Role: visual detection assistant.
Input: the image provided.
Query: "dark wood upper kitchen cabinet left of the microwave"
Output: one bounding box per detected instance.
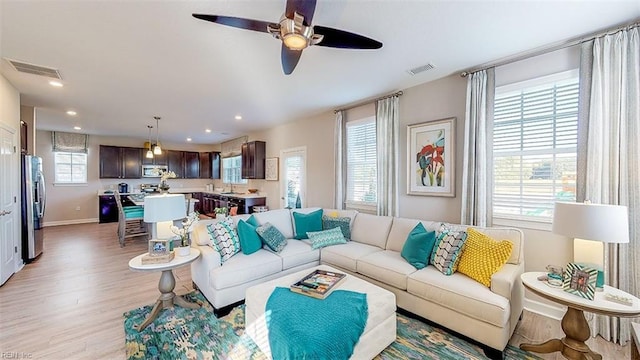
[100,145,142,179]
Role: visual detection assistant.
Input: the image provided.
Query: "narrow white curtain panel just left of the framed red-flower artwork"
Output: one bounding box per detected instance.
[376,95,399,216]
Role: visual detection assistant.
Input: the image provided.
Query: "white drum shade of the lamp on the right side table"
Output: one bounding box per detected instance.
[552,202,629,243]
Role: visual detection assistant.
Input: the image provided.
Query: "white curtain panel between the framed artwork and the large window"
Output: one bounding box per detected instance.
[460,68,495,226]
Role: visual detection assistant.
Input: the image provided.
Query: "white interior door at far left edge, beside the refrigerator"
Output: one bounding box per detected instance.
[0,125,19,284]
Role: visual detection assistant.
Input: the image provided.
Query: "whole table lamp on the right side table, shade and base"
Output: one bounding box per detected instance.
[552,202,629,289]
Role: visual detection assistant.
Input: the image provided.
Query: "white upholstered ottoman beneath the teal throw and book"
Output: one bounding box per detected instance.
[244,265,396,359]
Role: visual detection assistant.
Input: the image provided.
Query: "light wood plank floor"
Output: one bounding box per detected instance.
[0,224,630,360]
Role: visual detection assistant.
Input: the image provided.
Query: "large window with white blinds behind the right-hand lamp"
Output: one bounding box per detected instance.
[493,70,578,222]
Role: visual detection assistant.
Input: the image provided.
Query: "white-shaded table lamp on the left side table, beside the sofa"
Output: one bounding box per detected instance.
[144,194,186,239]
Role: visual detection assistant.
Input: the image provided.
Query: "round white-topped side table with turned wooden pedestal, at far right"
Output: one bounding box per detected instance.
[520,272,640,360]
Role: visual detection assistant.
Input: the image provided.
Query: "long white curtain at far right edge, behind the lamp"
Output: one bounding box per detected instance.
[583,27,640,344]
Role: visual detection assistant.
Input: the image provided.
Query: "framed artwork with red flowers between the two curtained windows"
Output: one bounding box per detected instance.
[407,117,456,197]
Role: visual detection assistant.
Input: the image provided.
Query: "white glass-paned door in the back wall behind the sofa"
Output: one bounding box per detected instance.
[280,146,307,208]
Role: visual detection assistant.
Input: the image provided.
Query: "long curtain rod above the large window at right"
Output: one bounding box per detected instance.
[460,19,640,77]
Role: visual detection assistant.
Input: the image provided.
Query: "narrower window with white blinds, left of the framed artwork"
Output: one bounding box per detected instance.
[346,117,378,207]
